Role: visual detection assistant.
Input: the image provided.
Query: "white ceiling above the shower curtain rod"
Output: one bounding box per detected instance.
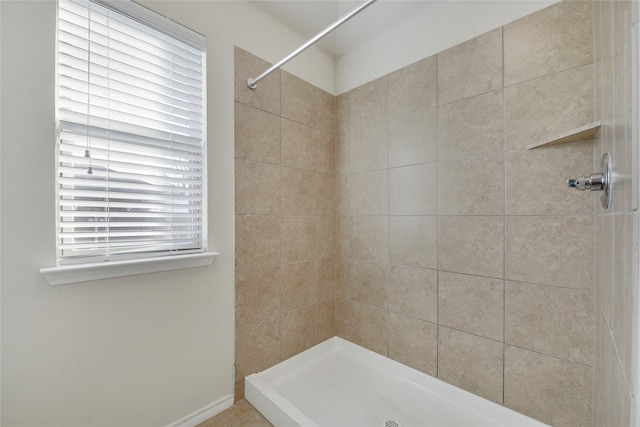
[251,0,439,59]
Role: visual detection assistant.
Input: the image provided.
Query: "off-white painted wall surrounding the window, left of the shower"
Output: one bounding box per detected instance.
[0,0,334,427]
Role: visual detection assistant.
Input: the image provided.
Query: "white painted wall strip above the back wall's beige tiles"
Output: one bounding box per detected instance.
[335,0,557,94]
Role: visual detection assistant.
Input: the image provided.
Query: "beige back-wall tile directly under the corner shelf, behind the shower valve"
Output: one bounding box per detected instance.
[506,142,599,215]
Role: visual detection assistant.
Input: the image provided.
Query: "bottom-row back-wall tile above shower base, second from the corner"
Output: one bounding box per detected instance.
[350,302,389,356]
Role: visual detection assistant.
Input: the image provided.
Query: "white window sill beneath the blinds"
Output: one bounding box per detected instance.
[40,252,220,285]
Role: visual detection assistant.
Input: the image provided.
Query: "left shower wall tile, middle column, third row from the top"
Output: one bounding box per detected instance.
[281,167,316,215]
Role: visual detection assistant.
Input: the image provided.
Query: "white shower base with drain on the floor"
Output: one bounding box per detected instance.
[245,337,546,427]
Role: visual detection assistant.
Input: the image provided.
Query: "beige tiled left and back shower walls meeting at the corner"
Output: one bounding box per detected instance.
[235,2,597,426]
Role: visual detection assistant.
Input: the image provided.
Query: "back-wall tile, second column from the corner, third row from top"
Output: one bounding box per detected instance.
[350,169,389,215]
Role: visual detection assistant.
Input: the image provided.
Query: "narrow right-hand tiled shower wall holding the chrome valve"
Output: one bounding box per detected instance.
[593,1,640,427]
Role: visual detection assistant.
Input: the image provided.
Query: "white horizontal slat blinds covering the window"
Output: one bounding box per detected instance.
[57,0,206,264]
